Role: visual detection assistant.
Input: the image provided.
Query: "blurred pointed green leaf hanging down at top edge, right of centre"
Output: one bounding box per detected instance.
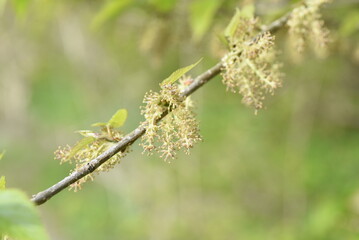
[189,0,221,42]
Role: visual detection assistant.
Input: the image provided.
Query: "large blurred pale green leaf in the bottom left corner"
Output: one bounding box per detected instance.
[0,189,49,240]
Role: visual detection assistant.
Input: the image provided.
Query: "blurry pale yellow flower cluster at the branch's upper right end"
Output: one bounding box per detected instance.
[287,0,330,62]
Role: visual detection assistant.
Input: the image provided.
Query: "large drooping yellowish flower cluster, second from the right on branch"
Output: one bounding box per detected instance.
[222,17,282,111]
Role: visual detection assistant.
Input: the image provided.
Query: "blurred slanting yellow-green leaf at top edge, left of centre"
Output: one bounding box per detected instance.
[91,0,133,29]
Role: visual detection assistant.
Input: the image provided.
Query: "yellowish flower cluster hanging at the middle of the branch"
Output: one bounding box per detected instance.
[141,79,201,161]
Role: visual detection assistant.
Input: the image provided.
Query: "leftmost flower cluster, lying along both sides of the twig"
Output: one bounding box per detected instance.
[55,127,128,192]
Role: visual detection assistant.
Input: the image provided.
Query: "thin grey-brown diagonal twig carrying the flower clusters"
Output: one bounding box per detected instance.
[31,14,290,205]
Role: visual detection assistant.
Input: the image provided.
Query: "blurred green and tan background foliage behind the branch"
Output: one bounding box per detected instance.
[0,0,359,240]
